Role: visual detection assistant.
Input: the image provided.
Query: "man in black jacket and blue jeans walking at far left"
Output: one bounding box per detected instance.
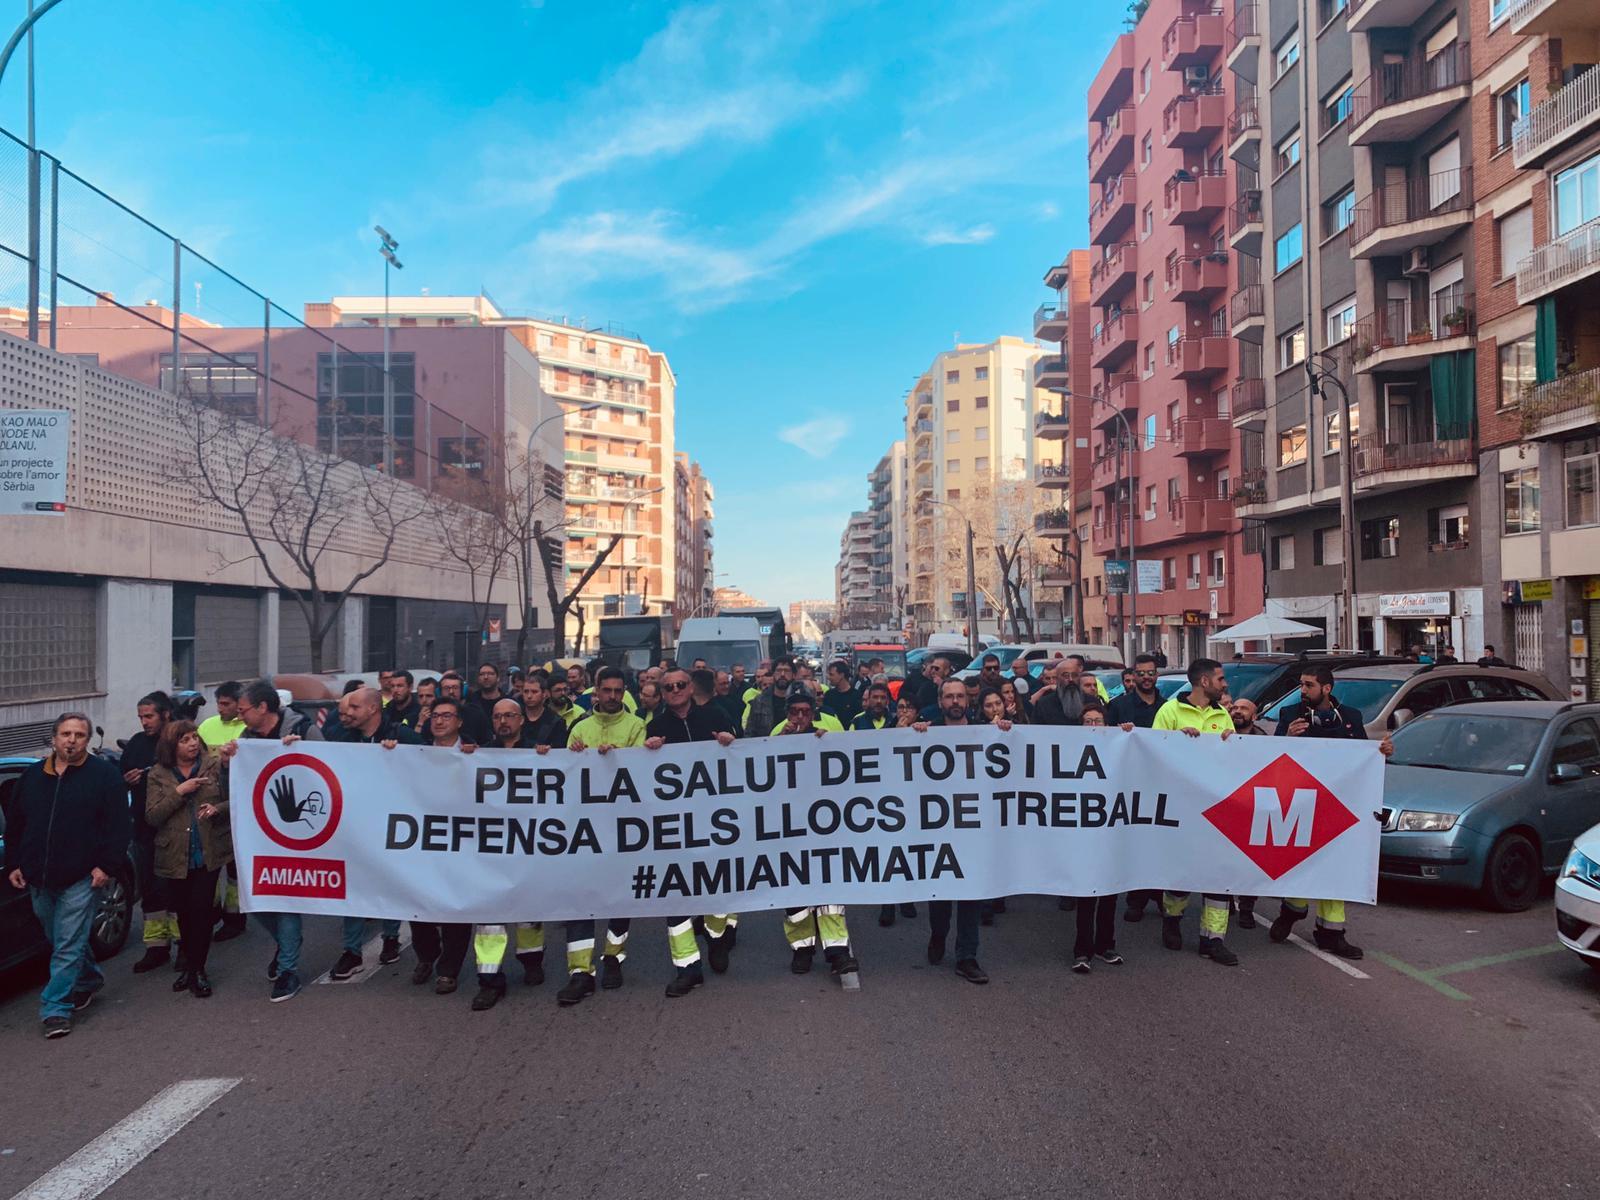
[5,712,133,1038]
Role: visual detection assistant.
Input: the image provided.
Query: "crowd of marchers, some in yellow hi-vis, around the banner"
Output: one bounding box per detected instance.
[5,654,1390,1037]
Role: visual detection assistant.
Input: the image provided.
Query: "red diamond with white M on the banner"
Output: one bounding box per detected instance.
[1205,754,1357,878]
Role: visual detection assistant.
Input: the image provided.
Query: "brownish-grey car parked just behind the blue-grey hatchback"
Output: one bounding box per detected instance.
[1261,662,1562,741]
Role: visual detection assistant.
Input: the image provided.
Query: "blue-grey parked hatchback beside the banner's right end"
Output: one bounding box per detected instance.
[1378,699,1600,912]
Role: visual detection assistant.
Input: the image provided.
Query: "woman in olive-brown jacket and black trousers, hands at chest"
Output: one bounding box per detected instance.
[144,722,234,1000]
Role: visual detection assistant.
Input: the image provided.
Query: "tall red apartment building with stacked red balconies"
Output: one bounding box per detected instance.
[1086,0,1262,662]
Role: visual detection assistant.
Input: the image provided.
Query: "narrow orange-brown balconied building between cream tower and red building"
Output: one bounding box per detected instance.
[1034,250,1106,642]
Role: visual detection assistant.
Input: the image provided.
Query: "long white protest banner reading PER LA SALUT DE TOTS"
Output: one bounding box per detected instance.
[230,726,1382,922]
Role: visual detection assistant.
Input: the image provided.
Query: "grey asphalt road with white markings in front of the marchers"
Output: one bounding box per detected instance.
[0,893,1600,1200]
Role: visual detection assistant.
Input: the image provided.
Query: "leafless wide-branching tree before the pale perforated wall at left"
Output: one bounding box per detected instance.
[173,397,426,672]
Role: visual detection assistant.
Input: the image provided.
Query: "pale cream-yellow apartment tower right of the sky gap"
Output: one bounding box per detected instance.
[904,336,1040,637]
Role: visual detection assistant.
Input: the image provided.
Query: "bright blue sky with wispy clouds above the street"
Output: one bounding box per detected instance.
[0,0,1123,603]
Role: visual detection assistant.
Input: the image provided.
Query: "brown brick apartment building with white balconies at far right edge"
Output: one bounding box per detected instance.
[1470,0,1600,698]
